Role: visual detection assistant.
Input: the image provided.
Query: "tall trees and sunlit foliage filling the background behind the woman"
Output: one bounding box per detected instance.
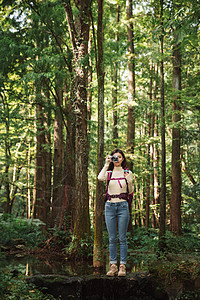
[0,0,200,299]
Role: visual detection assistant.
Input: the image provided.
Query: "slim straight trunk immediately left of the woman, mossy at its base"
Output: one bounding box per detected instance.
[93,0,104,268]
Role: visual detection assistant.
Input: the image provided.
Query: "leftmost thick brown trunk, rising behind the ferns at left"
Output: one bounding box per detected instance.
[32,82,51,229]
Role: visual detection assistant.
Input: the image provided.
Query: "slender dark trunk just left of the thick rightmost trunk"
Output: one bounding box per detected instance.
[159,0,166,249]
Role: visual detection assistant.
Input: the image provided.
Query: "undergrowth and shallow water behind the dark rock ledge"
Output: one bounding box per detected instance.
[0,216,200,299]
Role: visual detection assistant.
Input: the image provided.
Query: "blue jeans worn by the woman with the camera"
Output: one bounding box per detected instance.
[105,201,129,264]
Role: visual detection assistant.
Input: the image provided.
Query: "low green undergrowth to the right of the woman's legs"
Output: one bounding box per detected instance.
[127,228,200,270]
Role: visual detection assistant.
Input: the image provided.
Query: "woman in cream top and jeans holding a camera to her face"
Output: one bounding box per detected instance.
[98,149,133,276]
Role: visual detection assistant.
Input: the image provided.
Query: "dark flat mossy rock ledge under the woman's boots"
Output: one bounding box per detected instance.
[27,272,168,300]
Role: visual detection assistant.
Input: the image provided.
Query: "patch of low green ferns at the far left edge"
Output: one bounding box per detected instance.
[0,214,44,247]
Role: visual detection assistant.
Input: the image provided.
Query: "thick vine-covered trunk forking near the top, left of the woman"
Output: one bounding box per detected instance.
[63,0,90,241]
